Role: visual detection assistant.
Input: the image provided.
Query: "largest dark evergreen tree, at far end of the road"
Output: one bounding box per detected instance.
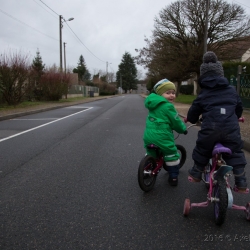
[116,52,138,93]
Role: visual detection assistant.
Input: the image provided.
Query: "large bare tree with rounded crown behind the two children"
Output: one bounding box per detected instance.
[136,0,250,86]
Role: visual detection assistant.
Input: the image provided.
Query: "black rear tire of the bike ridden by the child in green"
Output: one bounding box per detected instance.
[138,155,156,192]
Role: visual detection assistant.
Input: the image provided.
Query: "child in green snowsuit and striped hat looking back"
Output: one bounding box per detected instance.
[143,79,186,186]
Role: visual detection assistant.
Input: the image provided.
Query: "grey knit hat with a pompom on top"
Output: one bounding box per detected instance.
[200,51,224,76]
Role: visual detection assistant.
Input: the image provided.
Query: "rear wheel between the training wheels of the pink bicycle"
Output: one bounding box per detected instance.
[213,177,228,225]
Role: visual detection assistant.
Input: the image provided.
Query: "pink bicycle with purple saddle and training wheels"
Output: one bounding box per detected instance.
[183,117,250,225]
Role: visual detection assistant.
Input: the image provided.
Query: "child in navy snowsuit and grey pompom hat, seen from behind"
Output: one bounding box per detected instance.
[187,51,247,192]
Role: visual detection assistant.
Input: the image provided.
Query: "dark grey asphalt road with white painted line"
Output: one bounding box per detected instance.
[0,95,250,250]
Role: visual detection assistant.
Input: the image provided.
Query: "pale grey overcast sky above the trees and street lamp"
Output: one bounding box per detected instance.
[0,0,250,79]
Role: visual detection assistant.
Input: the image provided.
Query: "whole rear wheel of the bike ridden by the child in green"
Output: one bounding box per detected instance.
[138,155,156,192]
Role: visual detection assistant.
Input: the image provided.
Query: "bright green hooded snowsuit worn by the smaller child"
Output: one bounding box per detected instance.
[143,93,186,161]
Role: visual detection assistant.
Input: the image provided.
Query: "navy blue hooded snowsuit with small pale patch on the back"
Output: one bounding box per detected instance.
[187,74,243,164]
